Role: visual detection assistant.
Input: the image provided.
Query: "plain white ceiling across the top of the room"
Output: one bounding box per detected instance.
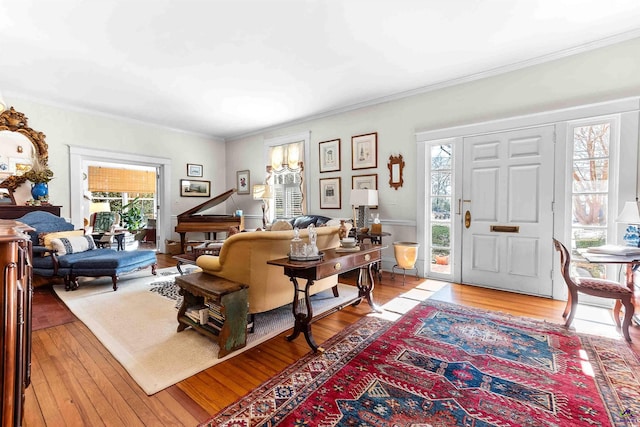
[0,0,640,138]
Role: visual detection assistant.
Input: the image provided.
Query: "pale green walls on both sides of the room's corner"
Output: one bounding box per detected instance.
[3,39,640,231]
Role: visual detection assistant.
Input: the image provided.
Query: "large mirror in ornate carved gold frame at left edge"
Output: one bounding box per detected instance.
[0,107,49,195]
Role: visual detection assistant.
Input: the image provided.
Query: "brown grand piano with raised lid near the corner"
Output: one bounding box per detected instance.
[176,189,244,252]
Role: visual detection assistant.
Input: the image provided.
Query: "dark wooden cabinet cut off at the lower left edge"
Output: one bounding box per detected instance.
[0,220,33,427]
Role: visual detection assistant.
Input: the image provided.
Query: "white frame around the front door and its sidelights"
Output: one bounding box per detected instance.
[415,97,640,299]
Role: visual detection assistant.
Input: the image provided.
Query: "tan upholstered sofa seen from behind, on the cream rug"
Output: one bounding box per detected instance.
[196,226,340,314]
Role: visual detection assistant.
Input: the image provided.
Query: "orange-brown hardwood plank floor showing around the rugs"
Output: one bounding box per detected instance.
[24,254,640,427]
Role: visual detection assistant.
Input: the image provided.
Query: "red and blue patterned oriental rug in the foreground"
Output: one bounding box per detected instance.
[202,300,640,427]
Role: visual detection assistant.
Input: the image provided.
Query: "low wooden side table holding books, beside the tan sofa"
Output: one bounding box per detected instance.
[176,273,249,358]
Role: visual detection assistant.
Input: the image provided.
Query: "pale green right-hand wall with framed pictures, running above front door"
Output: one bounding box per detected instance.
[227,39,640,231]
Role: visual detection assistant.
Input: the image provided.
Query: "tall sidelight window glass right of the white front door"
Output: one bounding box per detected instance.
[571,122,611,278]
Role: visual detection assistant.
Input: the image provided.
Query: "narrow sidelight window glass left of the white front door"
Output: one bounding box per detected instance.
[429,144,453,274]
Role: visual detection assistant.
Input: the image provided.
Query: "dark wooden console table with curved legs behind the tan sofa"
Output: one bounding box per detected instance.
[267,244,385,352]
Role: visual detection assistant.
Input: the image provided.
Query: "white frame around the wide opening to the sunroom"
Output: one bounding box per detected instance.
[69,145,171,253]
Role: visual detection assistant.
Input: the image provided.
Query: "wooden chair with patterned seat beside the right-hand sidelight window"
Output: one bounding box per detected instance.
[553,239,634,341]
